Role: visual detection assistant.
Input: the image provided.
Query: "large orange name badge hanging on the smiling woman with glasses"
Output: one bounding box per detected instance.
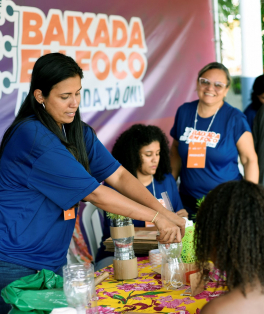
[187,142,206,168]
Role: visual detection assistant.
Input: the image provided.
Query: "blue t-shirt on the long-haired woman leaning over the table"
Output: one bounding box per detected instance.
[0,118,120,271]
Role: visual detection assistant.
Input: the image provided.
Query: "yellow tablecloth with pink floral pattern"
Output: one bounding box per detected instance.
[96,257,224,314]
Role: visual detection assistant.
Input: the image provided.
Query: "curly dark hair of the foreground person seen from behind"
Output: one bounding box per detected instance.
[194,180,264,295]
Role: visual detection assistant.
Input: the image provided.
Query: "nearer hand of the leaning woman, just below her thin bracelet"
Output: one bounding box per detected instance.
[154,213,185,244]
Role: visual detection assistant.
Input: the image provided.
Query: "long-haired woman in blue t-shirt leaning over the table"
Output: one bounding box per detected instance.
[0,53,185,314]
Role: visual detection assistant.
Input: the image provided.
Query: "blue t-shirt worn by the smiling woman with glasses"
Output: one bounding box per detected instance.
[170,100,251,199]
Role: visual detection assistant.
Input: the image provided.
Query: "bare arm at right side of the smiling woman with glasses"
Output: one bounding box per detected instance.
[236,131,259,184]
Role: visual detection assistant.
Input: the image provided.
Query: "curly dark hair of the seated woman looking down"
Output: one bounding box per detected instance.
[112,124,171,181]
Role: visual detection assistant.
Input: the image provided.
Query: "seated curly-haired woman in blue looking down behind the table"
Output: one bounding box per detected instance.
[96,124,188,262]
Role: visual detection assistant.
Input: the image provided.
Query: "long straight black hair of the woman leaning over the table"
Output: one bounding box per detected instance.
[0,53,89,170]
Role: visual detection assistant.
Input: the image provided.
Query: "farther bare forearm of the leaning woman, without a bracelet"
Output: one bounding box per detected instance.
[105,166,185,236]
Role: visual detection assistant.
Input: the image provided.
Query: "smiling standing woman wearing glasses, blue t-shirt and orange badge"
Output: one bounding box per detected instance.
[170,62,259,217]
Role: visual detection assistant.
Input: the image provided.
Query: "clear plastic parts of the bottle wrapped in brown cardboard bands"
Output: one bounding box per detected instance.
[110,218,135,260]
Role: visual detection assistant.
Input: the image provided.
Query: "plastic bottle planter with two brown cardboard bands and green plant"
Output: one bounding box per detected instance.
[106,213,138,280]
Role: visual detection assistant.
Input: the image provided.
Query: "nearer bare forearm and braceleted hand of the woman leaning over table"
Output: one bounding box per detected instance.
[84,184,182,243]
